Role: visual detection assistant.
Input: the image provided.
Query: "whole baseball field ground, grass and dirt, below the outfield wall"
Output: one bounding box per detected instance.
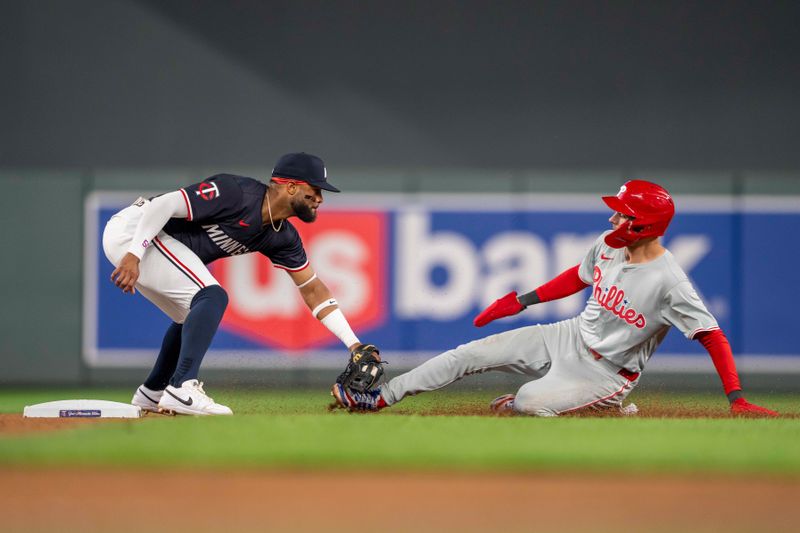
[0,388,800,533]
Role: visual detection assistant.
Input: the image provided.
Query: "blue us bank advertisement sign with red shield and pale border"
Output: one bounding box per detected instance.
[84,193,800,370]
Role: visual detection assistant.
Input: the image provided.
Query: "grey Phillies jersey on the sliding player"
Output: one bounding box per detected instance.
[579,232,719,372]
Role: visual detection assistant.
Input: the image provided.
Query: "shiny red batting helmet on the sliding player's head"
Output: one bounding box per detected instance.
[603,180,675,248]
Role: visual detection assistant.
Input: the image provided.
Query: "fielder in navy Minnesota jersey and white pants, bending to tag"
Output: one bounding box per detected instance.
[103,153,376,415]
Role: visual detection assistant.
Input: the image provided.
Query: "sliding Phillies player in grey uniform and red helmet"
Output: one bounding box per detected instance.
[332,180,777,416]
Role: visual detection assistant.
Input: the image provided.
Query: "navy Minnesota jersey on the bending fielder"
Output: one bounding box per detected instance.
[164,174,308,271]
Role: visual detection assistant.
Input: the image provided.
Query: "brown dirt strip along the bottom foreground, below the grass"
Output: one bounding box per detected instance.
[0,463,800,533]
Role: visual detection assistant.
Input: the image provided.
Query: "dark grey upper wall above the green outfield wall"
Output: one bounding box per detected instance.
[0,0,800,169]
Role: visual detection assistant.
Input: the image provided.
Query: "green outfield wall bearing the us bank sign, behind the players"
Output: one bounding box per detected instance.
[0,169,800,385]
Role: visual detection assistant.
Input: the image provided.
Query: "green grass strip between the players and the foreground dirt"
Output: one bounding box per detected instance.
[0,390,800,477]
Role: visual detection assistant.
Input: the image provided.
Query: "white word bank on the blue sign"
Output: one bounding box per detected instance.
[395,210,711,321]
